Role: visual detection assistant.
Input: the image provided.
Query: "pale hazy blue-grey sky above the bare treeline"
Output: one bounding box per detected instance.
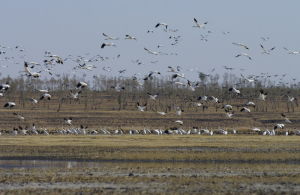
[0,0,300,80]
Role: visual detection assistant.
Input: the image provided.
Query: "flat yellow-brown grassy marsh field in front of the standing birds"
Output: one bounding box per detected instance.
[0,135,300,194]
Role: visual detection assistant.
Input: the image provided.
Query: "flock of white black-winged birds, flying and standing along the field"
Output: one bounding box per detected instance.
[0,18,300,135]
